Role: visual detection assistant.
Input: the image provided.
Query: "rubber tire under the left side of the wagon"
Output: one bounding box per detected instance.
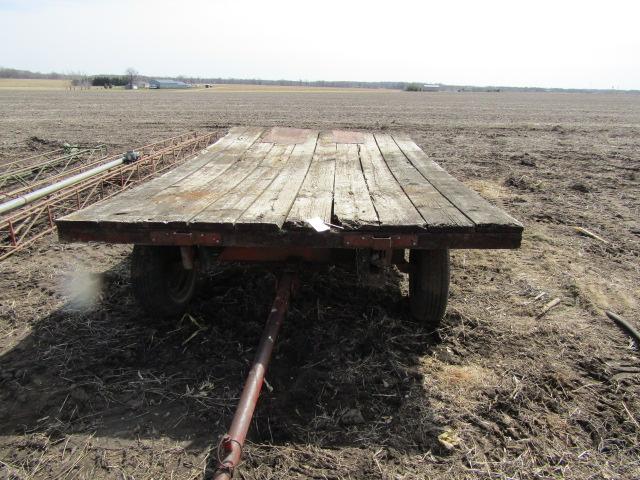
[131,245,198,318]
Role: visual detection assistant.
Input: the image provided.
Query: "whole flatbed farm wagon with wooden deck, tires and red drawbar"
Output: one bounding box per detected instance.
[56,127,523,478]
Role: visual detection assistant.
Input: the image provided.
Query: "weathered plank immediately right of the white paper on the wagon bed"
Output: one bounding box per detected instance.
[333,143,379,229]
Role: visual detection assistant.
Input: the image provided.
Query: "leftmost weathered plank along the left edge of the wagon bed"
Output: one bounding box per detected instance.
[68,127,247,220]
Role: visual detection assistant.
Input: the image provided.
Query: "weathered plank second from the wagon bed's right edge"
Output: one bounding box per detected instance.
[375,133,474,230]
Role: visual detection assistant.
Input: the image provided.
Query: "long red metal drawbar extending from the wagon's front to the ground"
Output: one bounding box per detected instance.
[213,272,295,480]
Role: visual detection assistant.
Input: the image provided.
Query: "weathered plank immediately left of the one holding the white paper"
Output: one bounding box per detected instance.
[236,131,318,230]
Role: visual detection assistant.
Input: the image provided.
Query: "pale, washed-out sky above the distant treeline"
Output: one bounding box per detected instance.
[0,0,640,89]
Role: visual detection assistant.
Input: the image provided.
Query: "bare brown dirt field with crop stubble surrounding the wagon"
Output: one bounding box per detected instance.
[0,89,640,480]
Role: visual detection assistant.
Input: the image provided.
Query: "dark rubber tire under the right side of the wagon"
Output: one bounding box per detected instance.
[409,250,449,330]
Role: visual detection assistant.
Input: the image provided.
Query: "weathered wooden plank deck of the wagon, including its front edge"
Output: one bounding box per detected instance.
[56,127,523,249]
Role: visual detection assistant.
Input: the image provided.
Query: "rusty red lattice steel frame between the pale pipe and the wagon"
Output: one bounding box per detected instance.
[0,132,215,261]
